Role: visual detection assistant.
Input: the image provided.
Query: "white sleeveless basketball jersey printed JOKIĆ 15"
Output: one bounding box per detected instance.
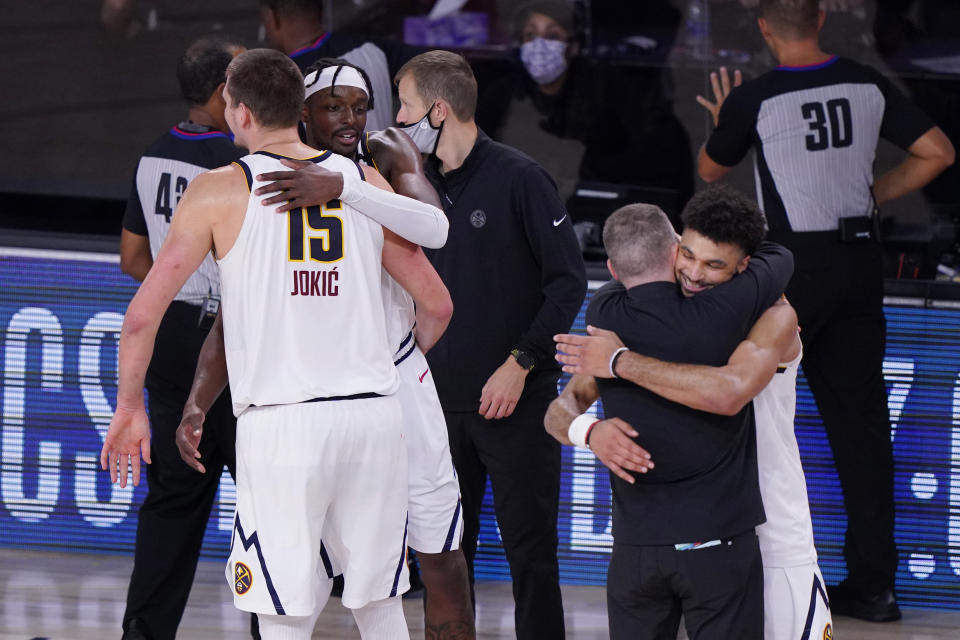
[218,151,399,416]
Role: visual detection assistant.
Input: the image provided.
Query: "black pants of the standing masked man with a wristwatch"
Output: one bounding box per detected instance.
[444,372,564,640]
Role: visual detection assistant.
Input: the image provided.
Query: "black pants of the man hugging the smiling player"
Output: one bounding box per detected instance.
[607,530,763,640]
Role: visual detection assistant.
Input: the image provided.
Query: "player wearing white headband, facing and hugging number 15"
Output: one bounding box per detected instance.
[178,58,475,638]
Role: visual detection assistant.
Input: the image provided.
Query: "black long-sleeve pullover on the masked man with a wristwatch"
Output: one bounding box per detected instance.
[426,131,586,411]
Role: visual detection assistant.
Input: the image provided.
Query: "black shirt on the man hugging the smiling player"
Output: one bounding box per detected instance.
[587,243,793,545]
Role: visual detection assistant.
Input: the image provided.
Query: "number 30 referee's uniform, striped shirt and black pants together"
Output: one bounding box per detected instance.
[706,57,934,596]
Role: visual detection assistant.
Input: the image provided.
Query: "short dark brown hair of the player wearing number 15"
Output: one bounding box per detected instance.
[227,49,304,129]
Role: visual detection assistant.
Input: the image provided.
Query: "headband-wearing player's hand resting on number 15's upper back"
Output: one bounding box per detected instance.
[253,158,343,213]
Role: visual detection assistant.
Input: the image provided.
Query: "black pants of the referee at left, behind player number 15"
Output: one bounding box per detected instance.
[123,302,236,640]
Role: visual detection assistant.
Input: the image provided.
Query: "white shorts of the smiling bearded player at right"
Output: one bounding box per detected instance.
[763,562,833,640]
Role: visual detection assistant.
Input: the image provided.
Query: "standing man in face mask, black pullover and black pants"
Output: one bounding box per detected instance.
[395,51,586,638]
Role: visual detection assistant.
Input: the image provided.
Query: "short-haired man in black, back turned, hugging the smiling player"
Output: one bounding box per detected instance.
[587,201,793,640]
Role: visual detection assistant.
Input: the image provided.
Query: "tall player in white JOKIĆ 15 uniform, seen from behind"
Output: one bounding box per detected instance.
[101,50,448,640]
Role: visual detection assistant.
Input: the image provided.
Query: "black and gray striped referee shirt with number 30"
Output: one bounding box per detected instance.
[706,56,934,231]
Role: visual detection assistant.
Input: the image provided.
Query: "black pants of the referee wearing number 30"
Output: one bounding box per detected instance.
[770,232,897,596]
